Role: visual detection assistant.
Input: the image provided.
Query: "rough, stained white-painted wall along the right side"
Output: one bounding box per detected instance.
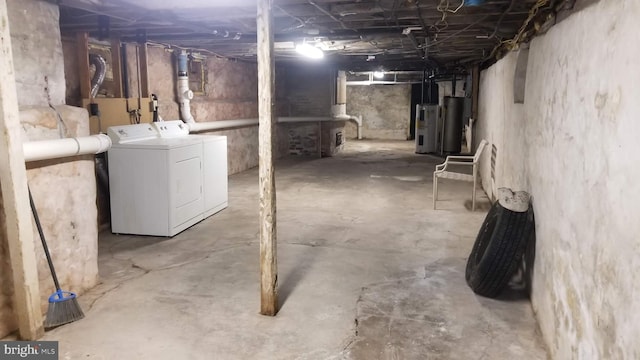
[477,0,640,359]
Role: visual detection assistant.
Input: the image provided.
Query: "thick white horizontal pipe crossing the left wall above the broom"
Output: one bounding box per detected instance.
[22,134,111,162]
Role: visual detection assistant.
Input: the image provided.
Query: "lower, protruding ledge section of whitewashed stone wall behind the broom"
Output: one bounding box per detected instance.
[0,105,98,337]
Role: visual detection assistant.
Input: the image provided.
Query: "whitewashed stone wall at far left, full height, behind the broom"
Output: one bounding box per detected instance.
[0,0,98,337]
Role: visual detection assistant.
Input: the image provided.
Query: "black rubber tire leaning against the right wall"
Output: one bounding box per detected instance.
[465,202,534,298]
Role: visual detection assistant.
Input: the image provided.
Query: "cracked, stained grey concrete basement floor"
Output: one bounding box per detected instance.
[45,141,546,359]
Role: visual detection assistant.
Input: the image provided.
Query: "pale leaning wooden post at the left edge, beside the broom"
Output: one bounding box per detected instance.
[0,0,44,340]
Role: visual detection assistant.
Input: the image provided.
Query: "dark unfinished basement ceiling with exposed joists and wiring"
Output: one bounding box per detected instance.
[57,0,564,70]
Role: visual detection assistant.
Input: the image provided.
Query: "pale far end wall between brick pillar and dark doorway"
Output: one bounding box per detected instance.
[345,84,411,140]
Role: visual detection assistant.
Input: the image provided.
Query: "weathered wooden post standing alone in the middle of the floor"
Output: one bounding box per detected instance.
[256,0,278,316]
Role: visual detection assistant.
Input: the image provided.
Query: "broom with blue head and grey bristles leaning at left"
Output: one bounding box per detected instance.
[29,189,84,329]
